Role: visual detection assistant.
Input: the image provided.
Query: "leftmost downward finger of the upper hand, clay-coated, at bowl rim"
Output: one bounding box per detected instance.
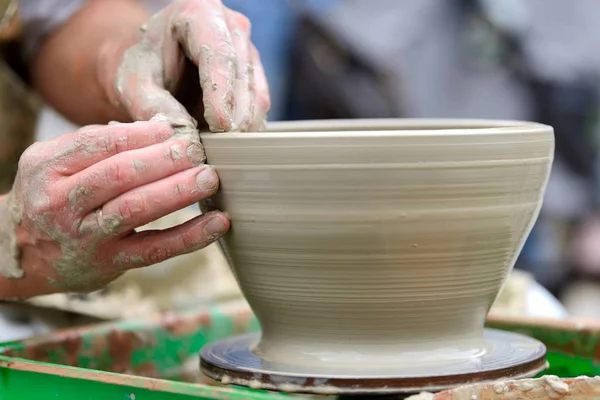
[173,0,238,132]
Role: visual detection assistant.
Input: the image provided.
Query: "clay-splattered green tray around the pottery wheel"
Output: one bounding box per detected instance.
[0,304,600,400]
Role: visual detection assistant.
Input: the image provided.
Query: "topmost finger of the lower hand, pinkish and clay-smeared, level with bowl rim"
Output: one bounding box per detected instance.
[50,122,174,175]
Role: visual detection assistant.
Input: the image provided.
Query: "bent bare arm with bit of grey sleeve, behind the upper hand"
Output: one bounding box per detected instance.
[21,0,149,125]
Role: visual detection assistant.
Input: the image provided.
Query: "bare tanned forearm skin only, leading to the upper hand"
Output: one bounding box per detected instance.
[31,0,149,125]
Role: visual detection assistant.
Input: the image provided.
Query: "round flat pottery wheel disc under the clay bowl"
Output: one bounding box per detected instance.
[200,329,547,395]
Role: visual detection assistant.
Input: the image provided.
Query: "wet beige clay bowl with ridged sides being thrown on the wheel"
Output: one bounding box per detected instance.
[202,120,554,375]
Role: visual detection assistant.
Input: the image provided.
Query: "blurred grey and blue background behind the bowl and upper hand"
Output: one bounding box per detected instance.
[38,0,600,318]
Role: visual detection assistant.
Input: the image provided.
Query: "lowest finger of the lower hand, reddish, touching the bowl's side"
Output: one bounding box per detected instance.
[113,212,230,269]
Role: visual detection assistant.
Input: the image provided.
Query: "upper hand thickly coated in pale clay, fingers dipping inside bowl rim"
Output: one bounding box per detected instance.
[99,0,269,133]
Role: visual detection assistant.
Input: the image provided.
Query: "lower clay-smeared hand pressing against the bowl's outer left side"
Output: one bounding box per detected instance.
[0,122,229,297]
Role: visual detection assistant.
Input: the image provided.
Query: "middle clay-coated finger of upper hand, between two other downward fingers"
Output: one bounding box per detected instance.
[225,10,255,132]
